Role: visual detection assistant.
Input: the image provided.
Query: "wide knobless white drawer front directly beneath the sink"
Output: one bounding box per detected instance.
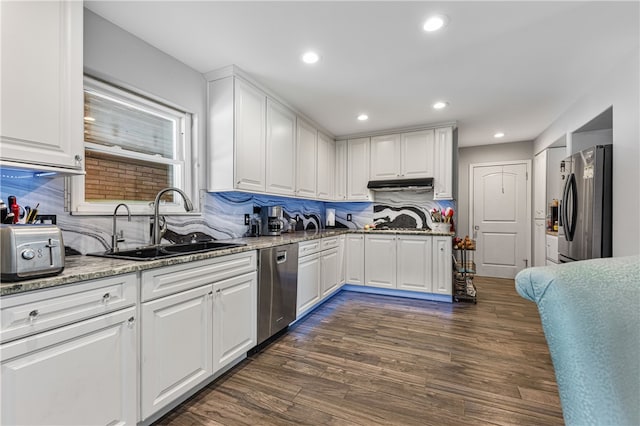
[142,250,257,302]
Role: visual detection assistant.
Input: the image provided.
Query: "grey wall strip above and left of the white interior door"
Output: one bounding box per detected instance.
[456,141,533,237]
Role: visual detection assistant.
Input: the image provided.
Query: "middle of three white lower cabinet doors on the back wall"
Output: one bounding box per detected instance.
[396,235,433,293]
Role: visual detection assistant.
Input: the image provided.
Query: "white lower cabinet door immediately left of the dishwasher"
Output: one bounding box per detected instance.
[213,272,258,371]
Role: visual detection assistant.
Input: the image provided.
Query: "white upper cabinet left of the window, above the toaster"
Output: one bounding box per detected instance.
[0,1,84,173]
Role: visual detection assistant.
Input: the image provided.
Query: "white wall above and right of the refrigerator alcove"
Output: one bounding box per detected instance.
[534,48,640,256]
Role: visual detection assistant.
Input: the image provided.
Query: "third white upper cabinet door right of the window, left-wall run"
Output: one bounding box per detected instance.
[296,119,318,197]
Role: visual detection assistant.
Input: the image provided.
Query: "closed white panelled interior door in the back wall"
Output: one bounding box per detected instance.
[469,160,531,278]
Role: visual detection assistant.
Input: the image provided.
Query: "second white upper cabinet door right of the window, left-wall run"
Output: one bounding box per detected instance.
[266,99,296,195]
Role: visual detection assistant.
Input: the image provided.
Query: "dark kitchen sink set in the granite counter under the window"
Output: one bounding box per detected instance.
[87,241,246,260]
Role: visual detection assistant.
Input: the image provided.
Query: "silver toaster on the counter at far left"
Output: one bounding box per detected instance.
[0,225,64,281]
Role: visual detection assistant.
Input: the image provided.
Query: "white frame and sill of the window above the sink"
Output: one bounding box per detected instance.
[65,75,200,216]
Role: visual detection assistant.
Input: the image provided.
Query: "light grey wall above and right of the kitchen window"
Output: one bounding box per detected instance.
[84,9,207,192]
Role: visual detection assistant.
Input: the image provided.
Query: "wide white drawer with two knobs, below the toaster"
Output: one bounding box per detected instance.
[0,274,137,342]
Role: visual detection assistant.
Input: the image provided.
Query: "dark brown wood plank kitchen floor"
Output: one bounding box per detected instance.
[157,277,563,426]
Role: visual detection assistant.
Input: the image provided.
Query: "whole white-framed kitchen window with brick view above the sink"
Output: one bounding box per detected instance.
[71,76,195,214]
